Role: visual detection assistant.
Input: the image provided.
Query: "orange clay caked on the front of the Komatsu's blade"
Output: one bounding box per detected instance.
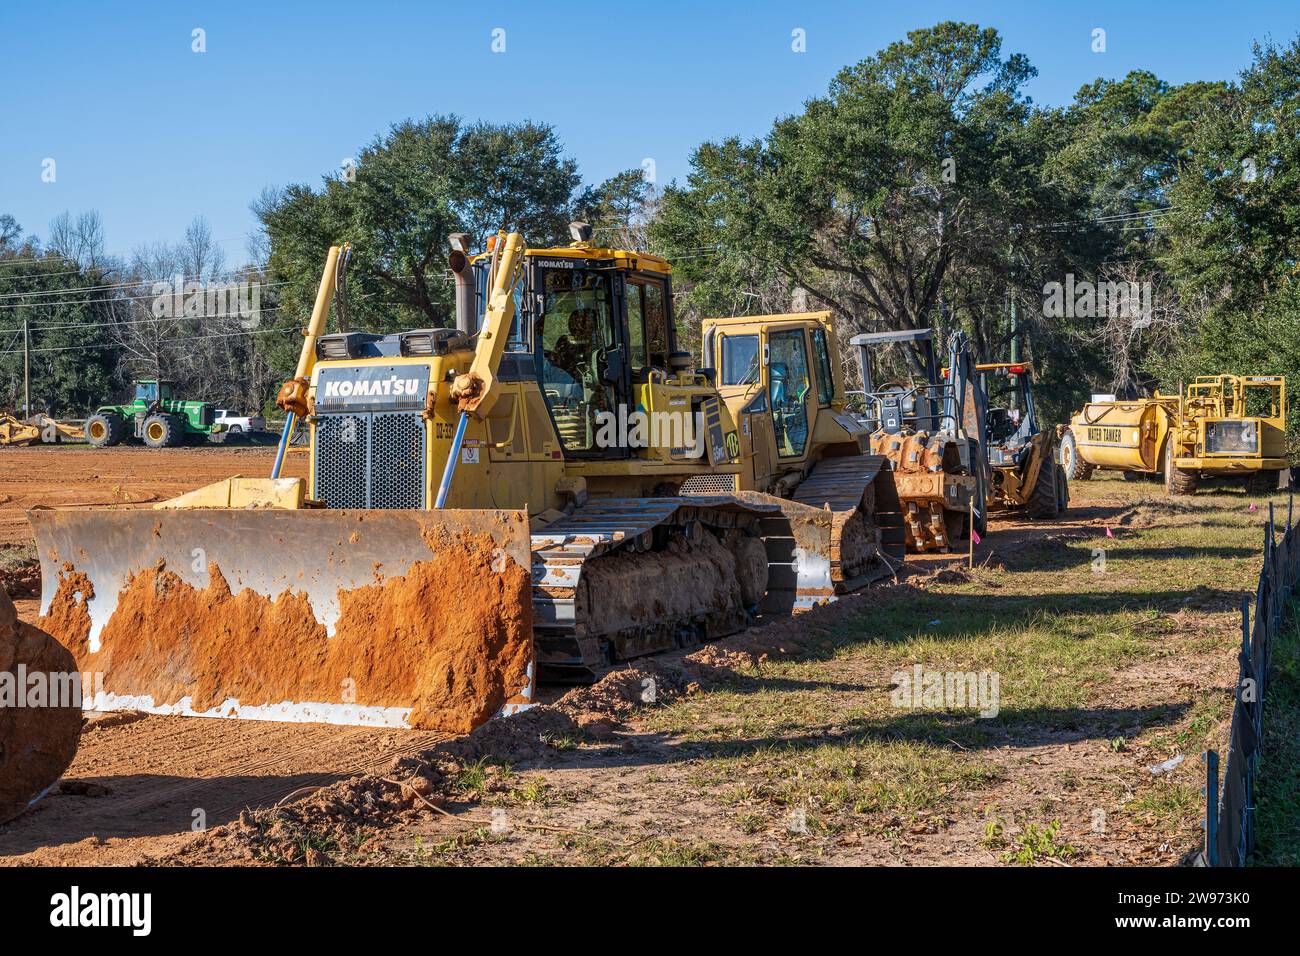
[40,535,532,734]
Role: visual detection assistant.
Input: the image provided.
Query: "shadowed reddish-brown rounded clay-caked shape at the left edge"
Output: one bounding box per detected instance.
[0,591,82,823]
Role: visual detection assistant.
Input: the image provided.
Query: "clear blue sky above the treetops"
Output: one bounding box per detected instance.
[0,0,1300,261]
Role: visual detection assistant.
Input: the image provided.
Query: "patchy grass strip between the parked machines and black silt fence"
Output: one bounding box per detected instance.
[361,479,1284,865]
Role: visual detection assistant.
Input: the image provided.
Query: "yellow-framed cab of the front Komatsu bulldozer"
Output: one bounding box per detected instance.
[458,233,738,476]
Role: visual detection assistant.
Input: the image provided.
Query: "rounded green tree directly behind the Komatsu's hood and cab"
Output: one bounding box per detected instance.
[254,116,579,369]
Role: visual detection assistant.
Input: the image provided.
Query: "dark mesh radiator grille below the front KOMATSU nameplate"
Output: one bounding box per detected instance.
[316,412,426,509]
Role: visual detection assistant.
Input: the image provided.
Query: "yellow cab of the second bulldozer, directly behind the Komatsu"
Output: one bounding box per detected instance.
[703,312,866,488]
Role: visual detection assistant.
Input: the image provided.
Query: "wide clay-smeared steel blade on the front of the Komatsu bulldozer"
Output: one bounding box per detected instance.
[27,509,534,732]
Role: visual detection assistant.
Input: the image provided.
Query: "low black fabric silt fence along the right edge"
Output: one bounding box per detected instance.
[1195,498,1300,866]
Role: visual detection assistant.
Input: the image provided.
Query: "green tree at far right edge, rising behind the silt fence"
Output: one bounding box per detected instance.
[1149,40,1300,424]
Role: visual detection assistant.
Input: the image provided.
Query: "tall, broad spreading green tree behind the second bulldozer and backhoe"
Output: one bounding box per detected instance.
[653,22,1086,403]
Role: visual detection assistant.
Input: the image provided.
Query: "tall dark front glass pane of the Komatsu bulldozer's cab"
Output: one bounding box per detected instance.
[536,269,616,451]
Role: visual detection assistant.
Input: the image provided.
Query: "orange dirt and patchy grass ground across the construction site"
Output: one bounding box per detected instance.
[0,449,1282,865]
